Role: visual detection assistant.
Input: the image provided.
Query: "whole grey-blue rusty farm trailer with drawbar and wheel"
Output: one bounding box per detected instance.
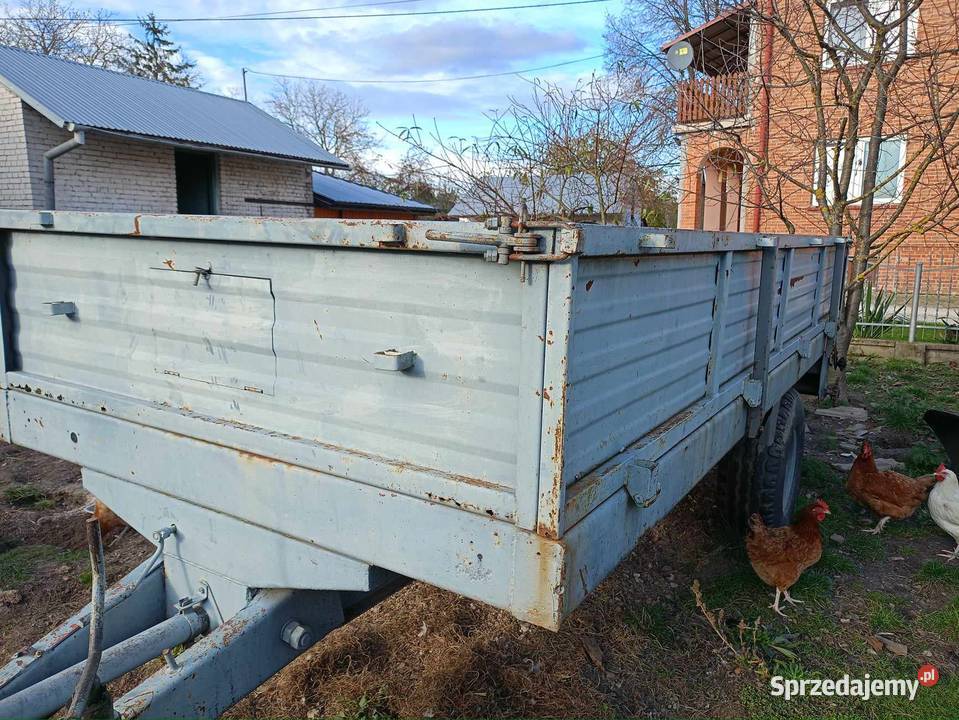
[0,211,846,717]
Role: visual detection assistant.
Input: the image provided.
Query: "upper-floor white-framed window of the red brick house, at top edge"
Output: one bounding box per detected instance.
[823,0,919,67]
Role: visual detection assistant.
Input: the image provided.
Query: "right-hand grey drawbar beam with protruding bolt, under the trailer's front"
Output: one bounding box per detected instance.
[114,590,344,718]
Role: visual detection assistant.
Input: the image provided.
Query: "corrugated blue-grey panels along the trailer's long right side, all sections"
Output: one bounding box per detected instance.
[563,247,835,484]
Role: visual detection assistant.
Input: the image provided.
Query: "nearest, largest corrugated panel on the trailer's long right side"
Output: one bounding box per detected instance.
[563,254,718,483]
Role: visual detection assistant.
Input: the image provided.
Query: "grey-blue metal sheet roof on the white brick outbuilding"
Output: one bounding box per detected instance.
[0,45,347,168]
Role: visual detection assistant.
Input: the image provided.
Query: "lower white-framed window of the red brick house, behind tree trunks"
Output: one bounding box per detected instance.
[813,136,906,205]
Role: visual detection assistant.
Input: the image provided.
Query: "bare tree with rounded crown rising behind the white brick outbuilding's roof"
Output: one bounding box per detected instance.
[267,79,378,180]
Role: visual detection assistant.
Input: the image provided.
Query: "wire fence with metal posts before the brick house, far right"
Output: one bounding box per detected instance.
[856,250,959,343]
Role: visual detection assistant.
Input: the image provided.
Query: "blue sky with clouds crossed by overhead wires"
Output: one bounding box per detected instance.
[88,0,623,170]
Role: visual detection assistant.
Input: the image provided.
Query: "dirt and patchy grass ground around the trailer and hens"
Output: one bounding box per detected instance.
[0,361,959,718]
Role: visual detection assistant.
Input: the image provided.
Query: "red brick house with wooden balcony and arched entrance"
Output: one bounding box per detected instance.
[663,0,959,270]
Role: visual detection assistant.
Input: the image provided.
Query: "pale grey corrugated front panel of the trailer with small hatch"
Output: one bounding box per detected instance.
[11,232,523,496]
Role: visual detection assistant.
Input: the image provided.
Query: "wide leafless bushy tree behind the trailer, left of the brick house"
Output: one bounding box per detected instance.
[386,75,663,222]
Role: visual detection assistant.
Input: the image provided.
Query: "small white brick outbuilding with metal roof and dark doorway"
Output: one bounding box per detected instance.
[0,46,346,217]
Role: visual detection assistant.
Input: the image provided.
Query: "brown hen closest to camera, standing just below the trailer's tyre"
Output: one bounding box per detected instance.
[746,500,829,617]
